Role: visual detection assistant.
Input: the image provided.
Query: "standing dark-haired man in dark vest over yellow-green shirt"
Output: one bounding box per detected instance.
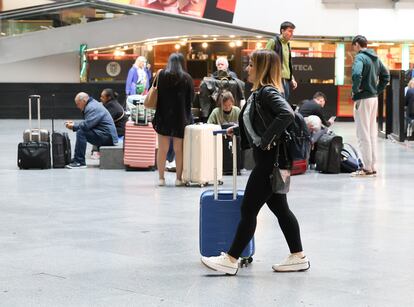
[266,21,298,100]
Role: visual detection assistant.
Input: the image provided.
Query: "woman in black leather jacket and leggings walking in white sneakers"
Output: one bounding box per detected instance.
[201,50,310,275]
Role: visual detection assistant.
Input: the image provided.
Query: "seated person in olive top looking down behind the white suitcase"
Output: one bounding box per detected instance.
[207,91,240,125]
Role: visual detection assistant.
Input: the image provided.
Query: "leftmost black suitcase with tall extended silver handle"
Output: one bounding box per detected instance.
[17,95,51,169]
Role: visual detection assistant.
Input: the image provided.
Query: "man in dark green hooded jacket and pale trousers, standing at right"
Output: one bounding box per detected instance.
[351,35,390,177]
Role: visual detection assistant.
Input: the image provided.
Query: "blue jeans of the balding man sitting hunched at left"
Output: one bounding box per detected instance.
[73,129,114,165]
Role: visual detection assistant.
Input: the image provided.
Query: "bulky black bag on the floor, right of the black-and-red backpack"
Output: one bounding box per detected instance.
[315,134,343,174]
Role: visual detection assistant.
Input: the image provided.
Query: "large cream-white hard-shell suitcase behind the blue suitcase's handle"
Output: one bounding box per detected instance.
[183,124,223,187]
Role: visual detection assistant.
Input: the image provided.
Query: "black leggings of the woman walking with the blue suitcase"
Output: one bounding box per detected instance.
[228,148,302,259]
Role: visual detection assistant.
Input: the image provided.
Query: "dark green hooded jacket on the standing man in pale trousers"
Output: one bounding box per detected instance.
[352,49,390,101]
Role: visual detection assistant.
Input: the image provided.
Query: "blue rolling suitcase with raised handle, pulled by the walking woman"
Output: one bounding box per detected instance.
[200,130,254,265]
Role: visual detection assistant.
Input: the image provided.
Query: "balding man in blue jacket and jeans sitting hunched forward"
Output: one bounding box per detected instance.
[65,92,118,168]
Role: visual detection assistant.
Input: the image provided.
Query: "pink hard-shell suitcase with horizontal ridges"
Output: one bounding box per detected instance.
[124,121,157,170]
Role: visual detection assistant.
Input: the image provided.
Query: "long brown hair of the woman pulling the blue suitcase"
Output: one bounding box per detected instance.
[250,49,283,93]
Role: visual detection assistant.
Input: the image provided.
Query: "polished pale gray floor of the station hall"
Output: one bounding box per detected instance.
[0,120,414,306]
